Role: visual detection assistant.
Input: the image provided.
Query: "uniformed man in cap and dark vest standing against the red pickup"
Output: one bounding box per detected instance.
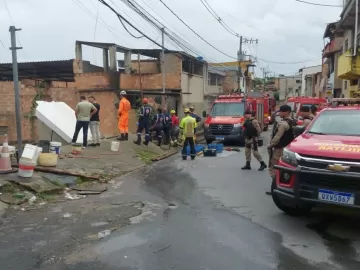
[266,105,296,195]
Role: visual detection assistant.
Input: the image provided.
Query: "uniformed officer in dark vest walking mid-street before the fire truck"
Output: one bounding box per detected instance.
[241,111,267,171]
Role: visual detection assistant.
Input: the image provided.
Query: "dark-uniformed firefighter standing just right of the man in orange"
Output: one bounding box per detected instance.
[134,98,153,145]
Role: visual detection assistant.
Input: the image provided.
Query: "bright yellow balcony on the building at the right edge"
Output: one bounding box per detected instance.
[338,48,360,80]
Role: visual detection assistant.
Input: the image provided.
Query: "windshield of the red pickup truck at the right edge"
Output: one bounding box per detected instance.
[308,110,360,136]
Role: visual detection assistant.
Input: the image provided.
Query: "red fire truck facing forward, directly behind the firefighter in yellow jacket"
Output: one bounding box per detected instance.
[203,94,269,145]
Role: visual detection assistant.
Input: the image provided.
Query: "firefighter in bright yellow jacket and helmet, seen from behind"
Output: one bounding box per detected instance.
[179,108,197,160]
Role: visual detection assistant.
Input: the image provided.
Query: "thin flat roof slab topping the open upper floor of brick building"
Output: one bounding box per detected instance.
[76,40,206,63]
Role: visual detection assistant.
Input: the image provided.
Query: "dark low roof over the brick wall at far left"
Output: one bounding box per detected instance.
[0,59,74,82]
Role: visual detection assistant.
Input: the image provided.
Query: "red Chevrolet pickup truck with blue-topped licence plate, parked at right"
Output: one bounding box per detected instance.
[271,99,360,215]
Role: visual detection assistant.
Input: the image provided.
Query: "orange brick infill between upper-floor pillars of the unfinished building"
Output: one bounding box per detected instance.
[120,73,181,90]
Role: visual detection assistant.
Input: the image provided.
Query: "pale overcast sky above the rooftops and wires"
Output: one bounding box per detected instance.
[0,0,342,75]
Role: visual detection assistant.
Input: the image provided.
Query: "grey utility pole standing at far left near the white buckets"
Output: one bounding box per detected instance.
[9,26,22,158]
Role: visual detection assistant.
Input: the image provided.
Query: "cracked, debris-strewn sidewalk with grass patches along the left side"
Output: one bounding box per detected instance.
[0,135,177,214]
